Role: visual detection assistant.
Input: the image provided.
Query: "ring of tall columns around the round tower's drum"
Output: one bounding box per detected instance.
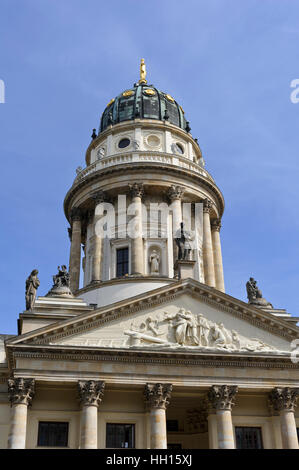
[69,183,224,292]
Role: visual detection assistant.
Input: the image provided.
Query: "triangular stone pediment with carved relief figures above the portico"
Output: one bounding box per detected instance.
[9,279,299,355]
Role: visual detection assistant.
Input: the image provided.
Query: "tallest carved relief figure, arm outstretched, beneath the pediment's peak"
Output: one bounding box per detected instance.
[165,308,199,346]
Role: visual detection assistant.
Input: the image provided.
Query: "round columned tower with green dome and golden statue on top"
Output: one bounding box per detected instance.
[64,59,224,306]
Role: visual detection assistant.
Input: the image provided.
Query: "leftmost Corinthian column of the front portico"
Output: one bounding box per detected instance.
[8,378,35,449]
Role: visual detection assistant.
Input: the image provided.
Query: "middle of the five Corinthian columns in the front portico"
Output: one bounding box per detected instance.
[144,383,172,449]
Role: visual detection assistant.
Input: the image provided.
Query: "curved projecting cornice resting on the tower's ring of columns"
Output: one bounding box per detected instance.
[64,162,224,222]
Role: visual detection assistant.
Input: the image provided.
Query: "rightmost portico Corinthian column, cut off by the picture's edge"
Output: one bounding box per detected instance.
[269,387,299,449]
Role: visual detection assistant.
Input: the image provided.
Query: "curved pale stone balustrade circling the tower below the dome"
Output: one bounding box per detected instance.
[73,152,214,185]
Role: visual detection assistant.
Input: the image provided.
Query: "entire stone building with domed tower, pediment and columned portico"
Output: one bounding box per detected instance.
[0,61,299,449]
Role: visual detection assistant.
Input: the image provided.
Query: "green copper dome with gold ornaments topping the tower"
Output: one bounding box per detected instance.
[99,80,191,133]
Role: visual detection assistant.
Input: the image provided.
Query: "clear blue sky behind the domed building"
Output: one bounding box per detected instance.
[0,0,299,334]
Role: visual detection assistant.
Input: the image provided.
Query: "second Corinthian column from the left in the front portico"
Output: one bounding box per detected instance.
[78,380,105,449]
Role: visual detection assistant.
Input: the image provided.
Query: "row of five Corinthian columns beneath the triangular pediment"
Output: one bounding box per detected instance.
[8,378,299,449]
